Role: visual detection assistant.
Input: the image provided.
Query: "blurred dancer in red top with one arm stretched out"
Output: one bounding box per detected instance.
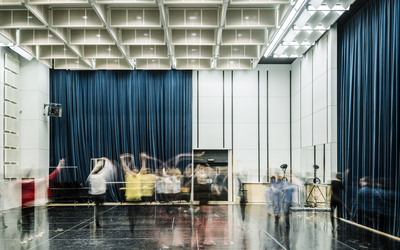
[20,159,65,244]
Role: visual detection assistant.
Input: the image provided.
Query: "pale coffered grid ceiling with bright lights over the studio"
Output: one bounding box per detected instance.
[0,0,354,70]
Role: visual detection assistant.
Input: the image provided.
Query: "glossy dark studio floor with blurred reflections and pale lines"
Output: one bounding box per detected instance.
[0,204,400,250]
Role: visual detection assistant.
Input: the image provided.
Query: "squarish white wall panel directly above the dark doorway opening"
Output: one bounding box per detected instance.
[199,122,223,148]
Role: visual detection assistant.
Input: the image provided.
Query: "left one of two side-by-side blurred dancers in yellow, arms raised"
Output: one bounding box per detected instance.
[120,154,142,235]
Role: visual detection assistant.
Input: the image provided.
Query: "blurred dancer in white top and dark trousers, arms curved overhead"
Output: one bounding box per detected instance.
[88,157,113,228]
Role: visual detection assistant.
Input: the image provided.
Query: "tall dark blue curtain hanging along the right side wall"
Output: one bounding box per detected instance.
[338,0,400,237]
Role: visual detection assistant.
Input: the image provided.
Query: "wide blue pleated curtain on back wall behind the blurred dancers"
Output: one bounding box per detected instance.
[50,70,192,201]
